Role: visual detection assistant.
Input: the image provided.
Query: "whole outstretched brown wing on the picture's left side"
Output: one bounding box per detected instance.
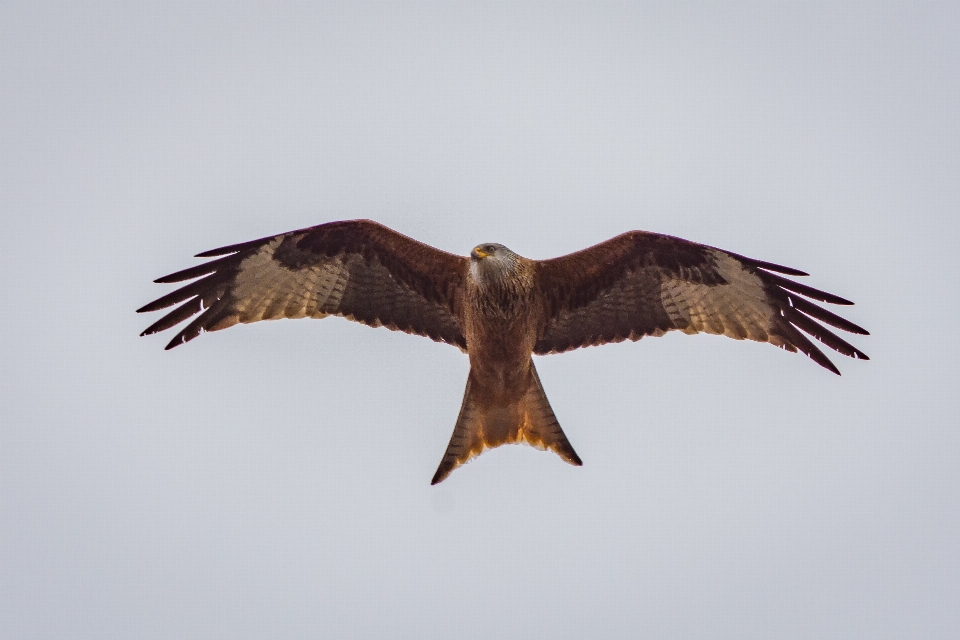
[137,220,467,349]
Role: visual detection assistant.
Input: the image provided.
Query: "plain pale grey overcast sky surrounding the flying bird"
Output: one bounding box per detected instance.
[0,0,960,639]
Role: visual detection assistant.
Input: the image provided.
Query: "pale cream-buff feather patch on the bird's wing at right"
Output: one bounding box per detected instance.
[660,251,774,342]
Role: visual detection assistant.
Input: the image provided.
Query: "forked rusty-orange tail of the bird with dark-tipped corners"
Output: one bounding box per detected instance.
[430,362,583,484]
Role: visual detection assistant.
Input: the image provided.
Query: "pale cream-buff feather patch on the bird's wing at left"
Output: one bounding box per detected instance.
[231,238,348,323]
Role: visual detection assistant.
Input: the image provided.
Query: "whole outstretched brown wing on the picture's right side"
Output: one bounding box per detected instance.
[534,231,868,375]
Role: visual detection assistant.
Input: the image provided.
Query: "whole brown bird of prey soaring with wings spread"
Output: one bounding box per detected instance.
[137,220,869,484]
